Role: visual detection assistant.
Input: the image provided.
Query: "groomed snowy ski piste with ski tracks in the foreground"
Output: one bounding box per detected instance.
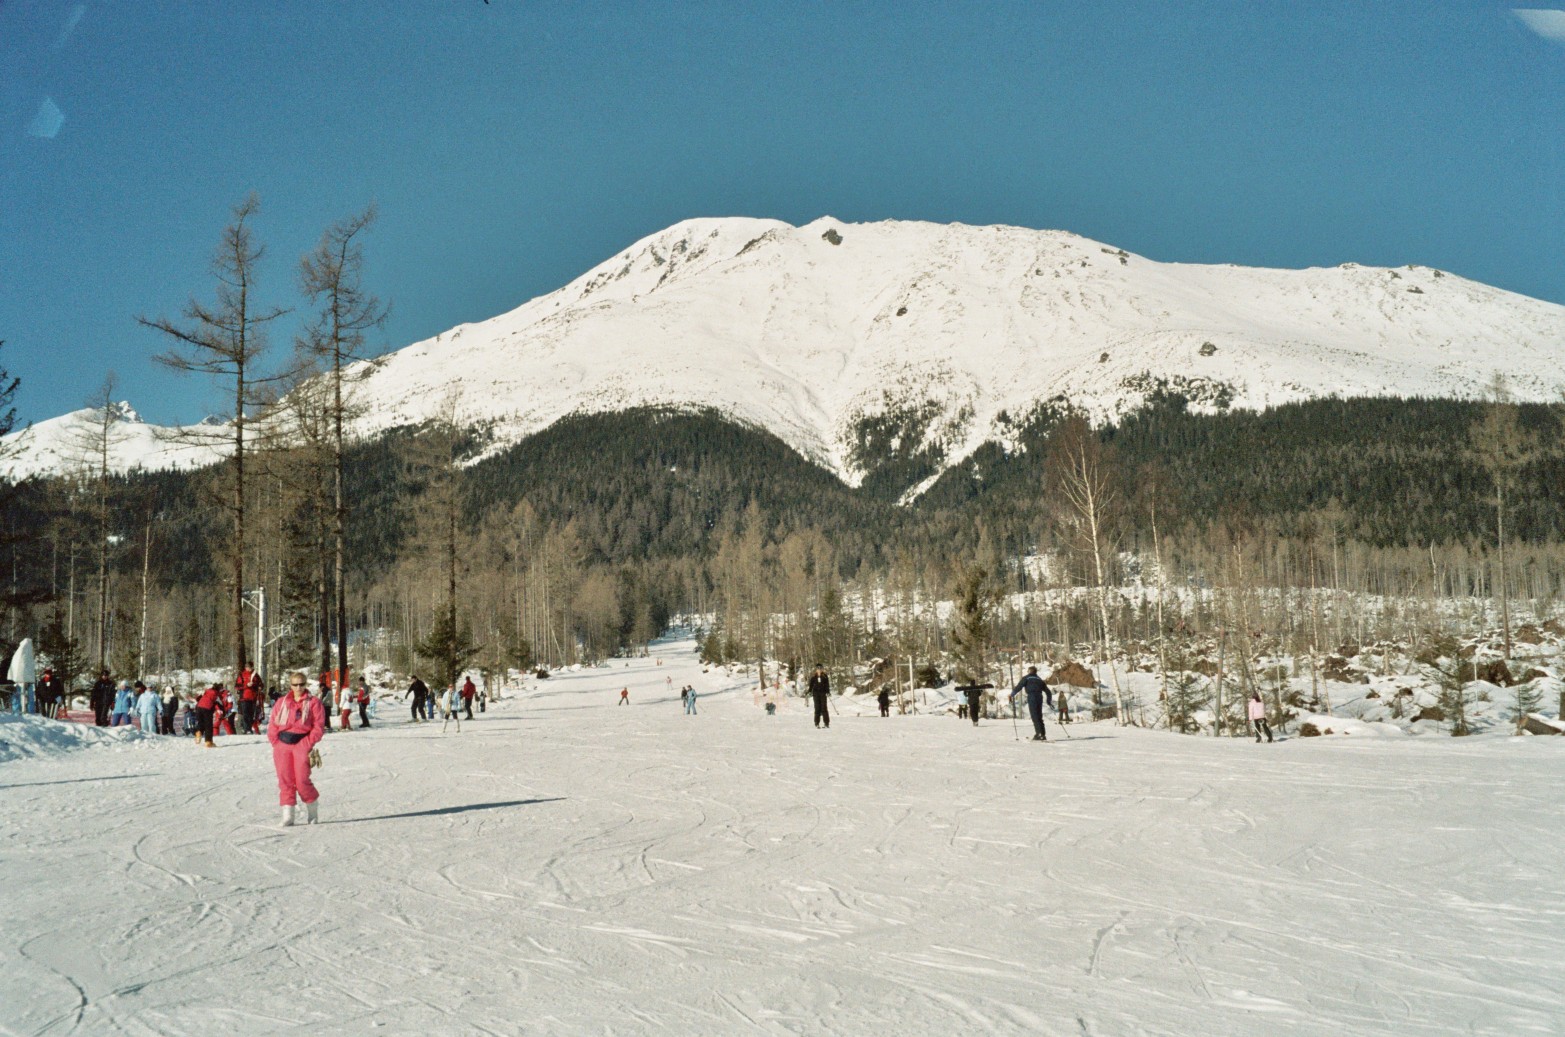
[0,644,1565,1037]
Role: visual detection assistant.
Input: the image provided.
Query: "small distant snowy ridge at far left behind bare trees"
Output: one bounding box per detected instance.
[0,402,224,479]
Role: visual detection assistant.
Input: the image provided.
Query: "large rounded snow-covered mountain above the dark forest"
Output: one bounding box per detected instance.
[6,217,1565,485]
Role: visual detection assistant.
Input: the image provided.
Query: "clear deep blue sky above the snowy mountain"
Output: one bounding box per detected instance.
[0,0,1565,422]
